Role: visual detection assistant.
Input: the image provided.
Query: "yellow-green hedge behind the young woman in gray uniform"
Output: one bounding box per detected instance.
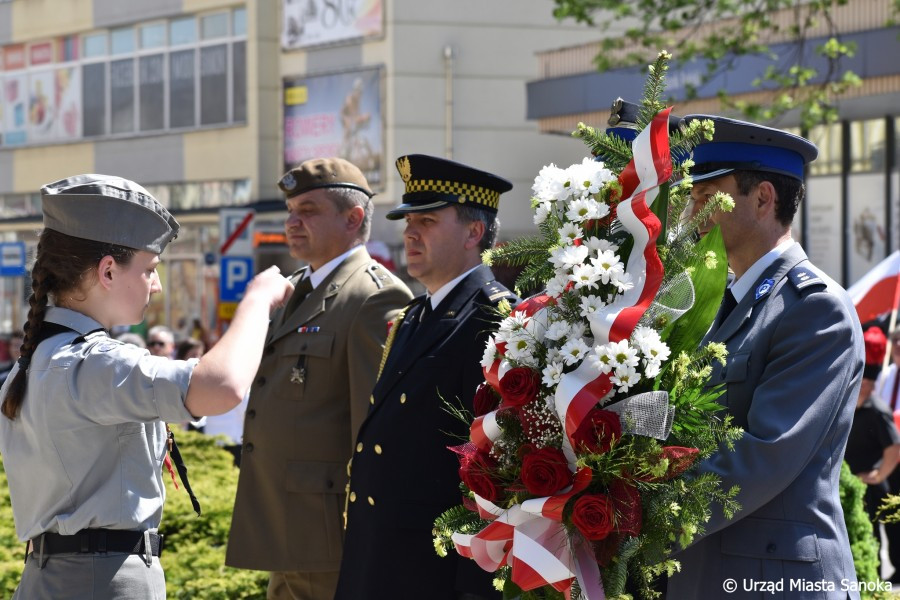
[0,431,269,600]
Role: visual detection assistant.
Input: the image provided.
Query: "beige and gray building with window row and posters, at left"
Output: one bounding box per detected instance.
[0,0,593,335]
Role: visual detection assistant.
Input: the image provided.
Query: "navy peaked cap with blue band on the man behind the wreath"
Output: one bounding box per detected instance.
[684,115,819,182]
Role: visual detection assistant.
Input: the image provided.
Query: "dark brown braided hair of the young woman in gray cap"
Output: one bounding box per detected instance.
[0,229,137,420]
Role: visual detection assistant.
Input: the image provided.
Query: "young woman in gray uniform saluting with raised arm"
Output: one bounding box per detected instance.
[0,175,292,600]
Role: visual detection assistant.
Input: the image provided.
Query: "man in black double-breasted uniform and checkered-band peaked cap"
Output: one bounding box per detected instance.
[335,154,518,600]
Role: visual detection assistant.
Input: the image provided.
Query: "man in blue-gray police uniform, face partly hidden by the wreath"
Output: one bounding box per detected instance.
[667,115,864,600]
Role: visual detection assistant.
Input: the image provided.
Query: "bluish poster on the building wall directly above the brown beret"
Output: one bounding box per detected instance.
[284,68,384,188]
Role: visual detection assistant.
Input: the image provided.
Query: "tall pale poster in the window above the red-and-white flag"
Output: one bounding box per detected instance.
[847,173,887,284]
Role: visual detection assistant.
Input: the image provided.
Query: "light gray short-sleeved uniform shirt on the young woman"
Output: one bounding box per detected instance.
[0,307,197,541]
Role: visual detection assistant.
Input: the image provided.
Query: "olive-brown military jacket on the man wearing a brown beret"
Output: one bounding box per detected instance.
[226,248,412,571]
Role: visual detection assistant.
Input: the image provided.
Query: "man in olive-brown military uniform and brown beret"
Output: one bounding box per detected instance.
[225,158,412,600]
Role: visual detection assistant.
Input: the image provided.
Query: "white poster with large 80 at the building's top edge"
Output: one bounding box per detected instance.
[281,0,384,50]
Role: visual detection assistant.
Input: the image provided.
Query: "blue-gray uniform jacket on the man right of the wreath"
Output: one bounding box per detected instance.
[667,244,864,600]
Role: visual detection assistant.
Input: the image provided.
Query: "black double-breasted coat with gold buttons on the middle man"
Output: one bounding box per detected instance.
[335,266,517,600]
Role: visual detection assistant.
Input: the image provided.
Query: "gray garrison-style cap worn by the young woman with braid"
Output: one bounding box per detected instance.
[41,174,179,254]
